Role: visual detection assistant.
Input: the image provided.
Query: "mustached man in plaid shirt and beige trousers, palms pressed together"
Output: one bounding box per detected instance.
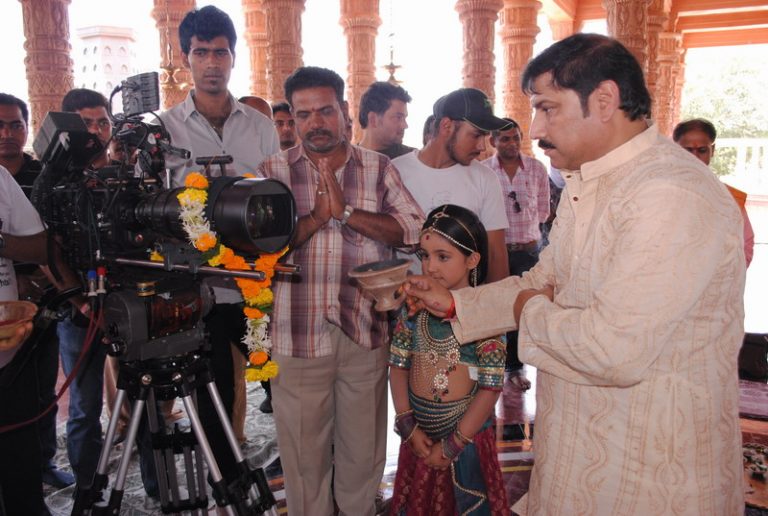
[257,67,424,516]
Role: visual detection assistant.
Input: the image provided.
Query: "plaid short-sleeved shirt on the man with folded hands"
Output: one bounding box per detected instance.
[256,145,424,358]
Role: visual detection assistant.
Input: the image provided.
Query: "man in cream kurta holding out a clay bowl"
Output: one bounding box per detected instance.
[408,34,745,516]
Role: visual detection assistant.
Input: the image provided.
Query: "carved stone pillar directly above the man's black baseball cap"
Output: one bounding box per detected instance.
[456,0,504,100]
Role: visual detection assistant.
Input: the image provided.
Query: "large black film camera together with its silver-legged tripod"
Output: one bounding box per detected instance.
[32,73,296,514]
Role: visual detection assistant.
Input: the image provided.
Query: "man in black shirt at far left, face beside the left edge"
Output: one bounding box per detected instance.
[0,93,75,488]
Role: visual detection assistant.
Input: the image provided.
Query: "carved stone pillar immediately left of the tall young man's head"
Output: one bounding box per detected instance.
[152,0,195,109]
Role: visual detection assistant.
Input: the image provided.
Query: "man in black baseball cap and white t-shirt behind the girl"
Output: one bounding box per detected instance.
[392,88,509,282]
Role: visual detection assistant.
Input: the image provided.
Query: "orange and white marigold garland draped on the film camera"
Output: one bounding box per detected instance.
[166,172,288,382]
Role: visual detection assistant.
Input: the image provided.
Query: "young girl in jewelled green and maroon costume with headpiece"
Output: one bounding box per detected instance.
[389,204,510,516]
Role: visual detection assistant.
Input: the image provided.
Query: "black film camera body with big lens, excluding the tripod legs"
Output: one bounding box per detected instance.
[32,74,296,360]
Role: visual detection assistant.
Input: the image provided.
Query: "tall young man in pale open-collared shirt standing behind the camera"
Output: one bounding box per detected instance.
[154,6,279,488]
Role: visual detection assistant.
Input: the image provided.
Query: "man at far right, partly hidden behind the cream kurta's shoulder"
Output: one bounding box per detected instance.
[672,118,755,267]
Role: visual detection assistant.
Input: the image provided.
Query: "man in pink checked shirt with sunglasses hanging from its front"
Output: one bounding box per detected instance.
[483,118,549,390]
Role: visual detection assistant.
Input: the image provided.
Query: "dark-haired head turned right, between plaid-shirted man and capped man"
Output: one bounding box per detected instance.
[358,82,414,159]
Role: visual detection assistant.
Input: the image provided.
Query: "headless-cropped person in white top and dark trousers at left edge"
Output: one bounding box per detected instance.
[0,166,48,515]
